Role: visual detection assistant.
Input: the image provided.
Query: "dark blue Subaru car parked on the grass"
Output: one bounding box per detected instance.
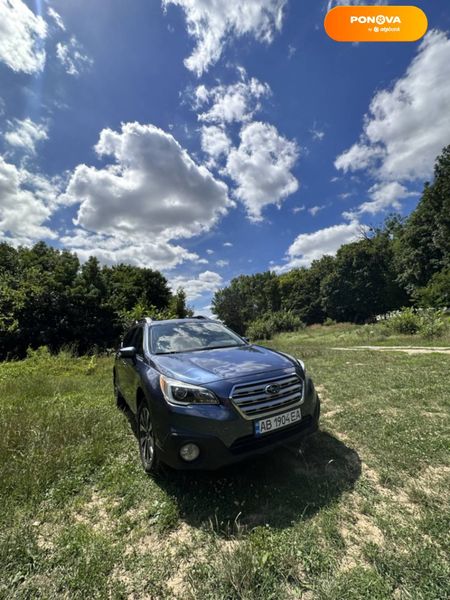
[113,317,320,473]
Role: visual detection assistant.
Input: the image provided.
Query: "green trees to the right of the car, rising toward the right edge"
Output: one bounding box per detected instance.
[212,146,450,334]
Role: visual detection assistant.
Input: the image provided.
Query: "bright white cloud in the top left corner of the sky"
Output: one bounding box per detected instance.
[0,0,47,73]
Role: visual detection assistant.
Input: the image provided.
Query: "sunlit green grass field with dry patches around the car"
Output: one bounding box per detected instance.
[0,326,450,600]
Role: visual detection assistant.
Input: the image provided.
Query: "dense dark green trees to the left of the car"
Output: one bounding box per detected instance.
[0,242,190,359]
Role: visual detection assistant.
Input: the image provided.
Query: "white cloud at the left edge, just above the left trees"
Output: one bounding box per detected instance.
[0,156,56,245]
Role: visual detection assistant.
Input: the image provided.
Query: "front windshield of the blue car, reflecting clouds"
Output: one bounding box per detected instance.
[151,322,245,354]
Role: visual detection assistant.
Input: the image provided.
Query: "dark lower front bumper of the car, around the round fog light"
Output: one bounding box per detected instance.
[158,387,320,470]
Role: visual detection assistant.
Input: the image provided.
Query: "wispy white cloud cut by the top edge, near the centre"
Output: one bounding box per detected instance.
[162,0,287,76]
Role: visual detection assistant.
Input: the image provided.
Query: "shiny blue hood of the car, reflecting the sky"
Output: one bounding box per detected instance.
[152,345,294,384]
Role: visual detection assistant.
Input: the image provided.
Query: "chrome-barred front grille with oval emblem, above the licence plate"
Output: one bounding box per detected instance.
[230,374,304,419]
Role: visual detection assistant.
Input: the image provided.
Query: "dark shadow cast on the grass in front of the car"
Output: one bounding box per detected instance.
[160,432,361,536]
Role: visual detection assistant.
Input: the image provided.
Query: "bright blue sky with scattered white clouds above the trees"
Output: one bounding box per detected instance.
[0,0,450,314]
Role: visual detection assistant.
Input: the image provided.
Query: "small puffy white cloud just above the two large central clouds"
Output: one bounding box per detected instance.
[195,76,271,124]
